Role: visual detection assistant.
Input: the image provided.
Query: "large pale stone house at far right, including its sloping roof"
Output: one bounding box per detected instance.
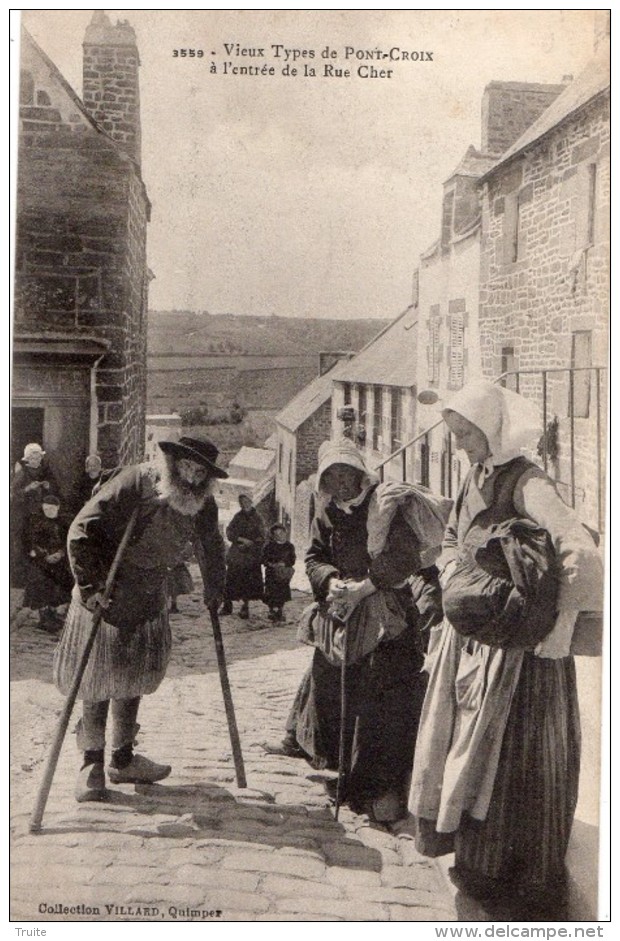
[479,31,610,530]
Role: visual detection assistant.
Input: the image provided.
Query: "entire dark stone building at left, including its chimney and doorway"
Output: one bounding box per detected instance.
[12,11,150,501]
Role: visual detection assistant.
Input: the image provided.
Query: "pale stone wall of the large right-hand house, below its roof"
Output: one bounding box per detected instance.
[479,95,610,528]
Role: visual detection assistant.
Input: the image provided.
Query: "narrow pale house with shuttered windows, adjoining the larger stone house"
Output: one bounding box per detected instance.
[411,82,564,496]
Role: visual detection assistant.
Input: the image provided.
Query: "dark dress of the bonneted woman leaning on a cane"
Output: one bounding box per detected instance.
[287,490,426,810]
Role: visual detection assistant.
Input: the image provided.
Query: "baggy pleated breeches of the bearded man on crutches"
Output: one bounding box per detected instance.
[54,589,172,702]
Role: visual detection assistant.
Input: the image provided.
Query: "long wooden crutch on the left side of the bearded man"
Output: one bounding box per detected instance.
[30,507,138,833]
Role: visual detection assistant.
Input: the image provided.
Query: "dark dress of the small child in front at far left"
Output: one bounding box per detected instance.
[24,510,73,610]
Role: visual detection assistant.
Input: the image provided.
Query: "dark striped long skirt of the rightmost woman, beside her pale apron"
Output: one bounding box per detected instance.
[455,653,581,899]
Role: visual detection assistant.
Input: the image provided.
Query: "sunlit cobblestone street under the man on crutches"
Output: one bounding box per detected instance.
[11,579,464,921]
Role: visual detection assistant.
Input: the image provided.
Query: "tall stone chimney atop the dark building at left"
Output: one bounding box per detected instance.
[82,10,140,164]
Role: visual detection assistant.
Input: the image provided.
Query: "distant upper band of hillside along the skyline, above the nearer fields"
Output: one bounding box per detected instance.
[148,310,388,356]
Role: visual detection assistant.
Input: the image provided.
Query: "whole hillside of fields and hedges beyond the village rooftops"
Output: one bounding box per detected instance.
[147,311,389,458]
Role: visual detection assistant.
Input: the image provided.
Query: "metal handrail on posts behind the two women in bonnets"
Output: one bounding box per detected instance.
[375,366,607,532]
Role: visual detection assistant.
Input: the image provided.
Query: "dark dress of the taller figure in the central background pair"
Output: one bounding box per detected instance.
[226,508,265,601]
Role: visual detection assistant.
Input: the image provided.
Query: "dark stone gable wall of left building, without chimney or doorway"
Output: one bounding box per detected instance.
[14,29,150,467]
